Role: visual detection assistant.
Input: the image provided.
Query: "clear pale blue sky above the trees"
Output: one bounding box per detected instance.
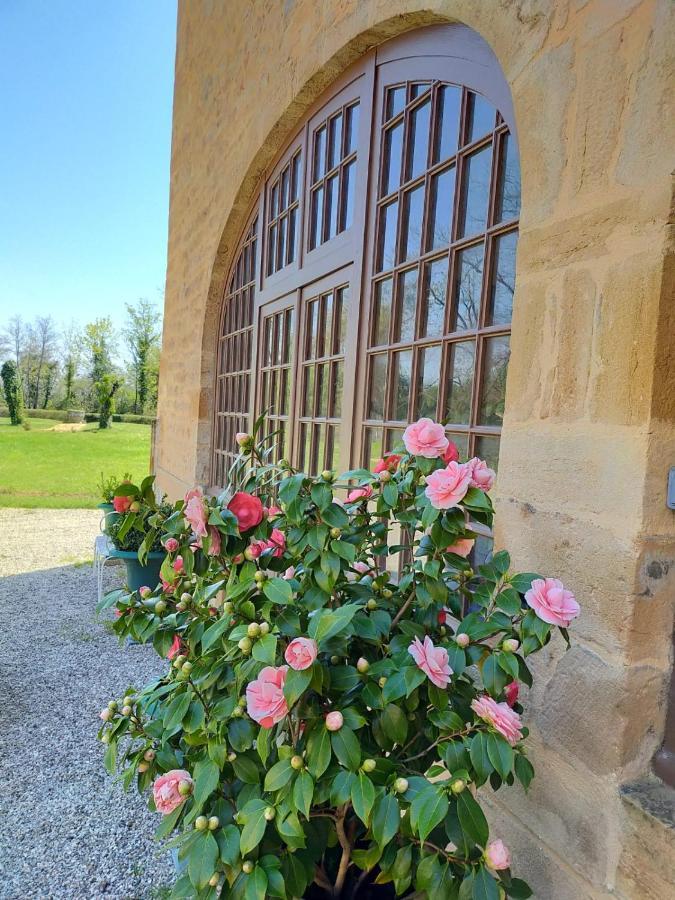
[0,0,176,327]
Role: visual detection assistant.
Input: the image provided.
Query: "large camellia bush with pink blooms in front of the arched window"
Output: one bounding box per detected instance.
[100,419,579,900]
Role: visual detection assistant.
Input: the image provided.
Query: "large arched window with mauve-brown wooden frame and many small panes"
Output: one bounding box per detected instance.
[212,25,520,556]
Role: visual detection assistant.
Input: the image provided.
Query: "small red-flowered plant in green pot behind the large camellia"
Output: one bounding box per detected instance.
[106,475,172,591]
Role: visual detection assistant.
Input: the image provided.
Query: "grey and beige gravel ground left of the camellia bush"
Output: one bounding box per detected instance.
[0,509,173,900]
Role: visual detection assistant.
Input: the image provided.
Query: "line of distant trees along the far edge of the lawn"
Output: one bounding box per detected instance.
[0,299,162,415]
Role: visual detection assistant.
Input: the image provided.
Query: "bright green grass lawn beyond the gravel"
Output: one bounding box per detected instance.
[0,418,150,509]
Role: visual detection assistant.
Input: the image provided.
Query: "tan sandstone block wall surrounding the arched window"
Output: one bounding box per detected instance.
[155,0,675,900]
